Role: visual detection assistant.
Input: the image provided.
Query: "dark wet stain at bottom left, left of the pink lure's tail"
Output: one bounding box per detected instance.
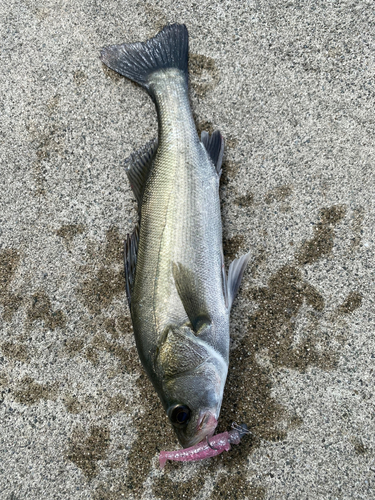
[66,426,110,480]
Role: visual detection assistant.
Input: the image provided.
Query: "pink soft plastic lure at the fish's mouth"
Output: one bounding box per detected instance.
[159,423,249,469]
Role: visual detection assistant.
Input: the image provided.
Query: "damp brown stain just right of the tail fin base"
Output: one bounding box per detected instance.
[189,52,220,97]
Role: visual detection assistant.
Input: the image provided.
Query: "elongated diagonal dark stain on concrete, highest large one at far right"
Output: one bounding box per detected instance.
[296,205,346,265]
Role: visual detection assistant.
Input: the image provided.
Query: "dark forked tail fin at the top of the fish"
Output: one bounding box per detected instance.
[100,24,189,90]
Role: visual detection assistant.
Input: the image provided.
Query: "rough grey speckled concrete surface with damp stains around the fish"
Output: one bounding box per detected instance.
[0,0,375,500]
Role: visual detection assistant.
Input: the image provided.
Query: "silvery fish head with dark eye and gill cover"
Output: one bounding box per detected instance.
[154,326,228,448]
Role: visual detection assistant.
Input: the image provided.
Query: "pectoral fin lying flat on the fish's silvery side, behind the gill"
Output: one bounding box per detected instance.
[172,263,211,335]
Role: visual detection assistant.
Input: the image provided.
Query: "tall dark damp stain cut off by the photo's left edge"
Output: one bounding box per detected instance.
[0,248,22,321]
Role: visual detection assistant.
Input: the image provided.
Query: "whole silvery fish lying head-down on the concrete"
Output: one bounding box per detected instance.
[100,24,250,448]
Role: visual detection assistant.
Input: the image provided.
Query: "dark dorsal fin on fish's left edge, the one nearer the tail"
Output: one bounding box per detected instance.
[125,139,158,213]
